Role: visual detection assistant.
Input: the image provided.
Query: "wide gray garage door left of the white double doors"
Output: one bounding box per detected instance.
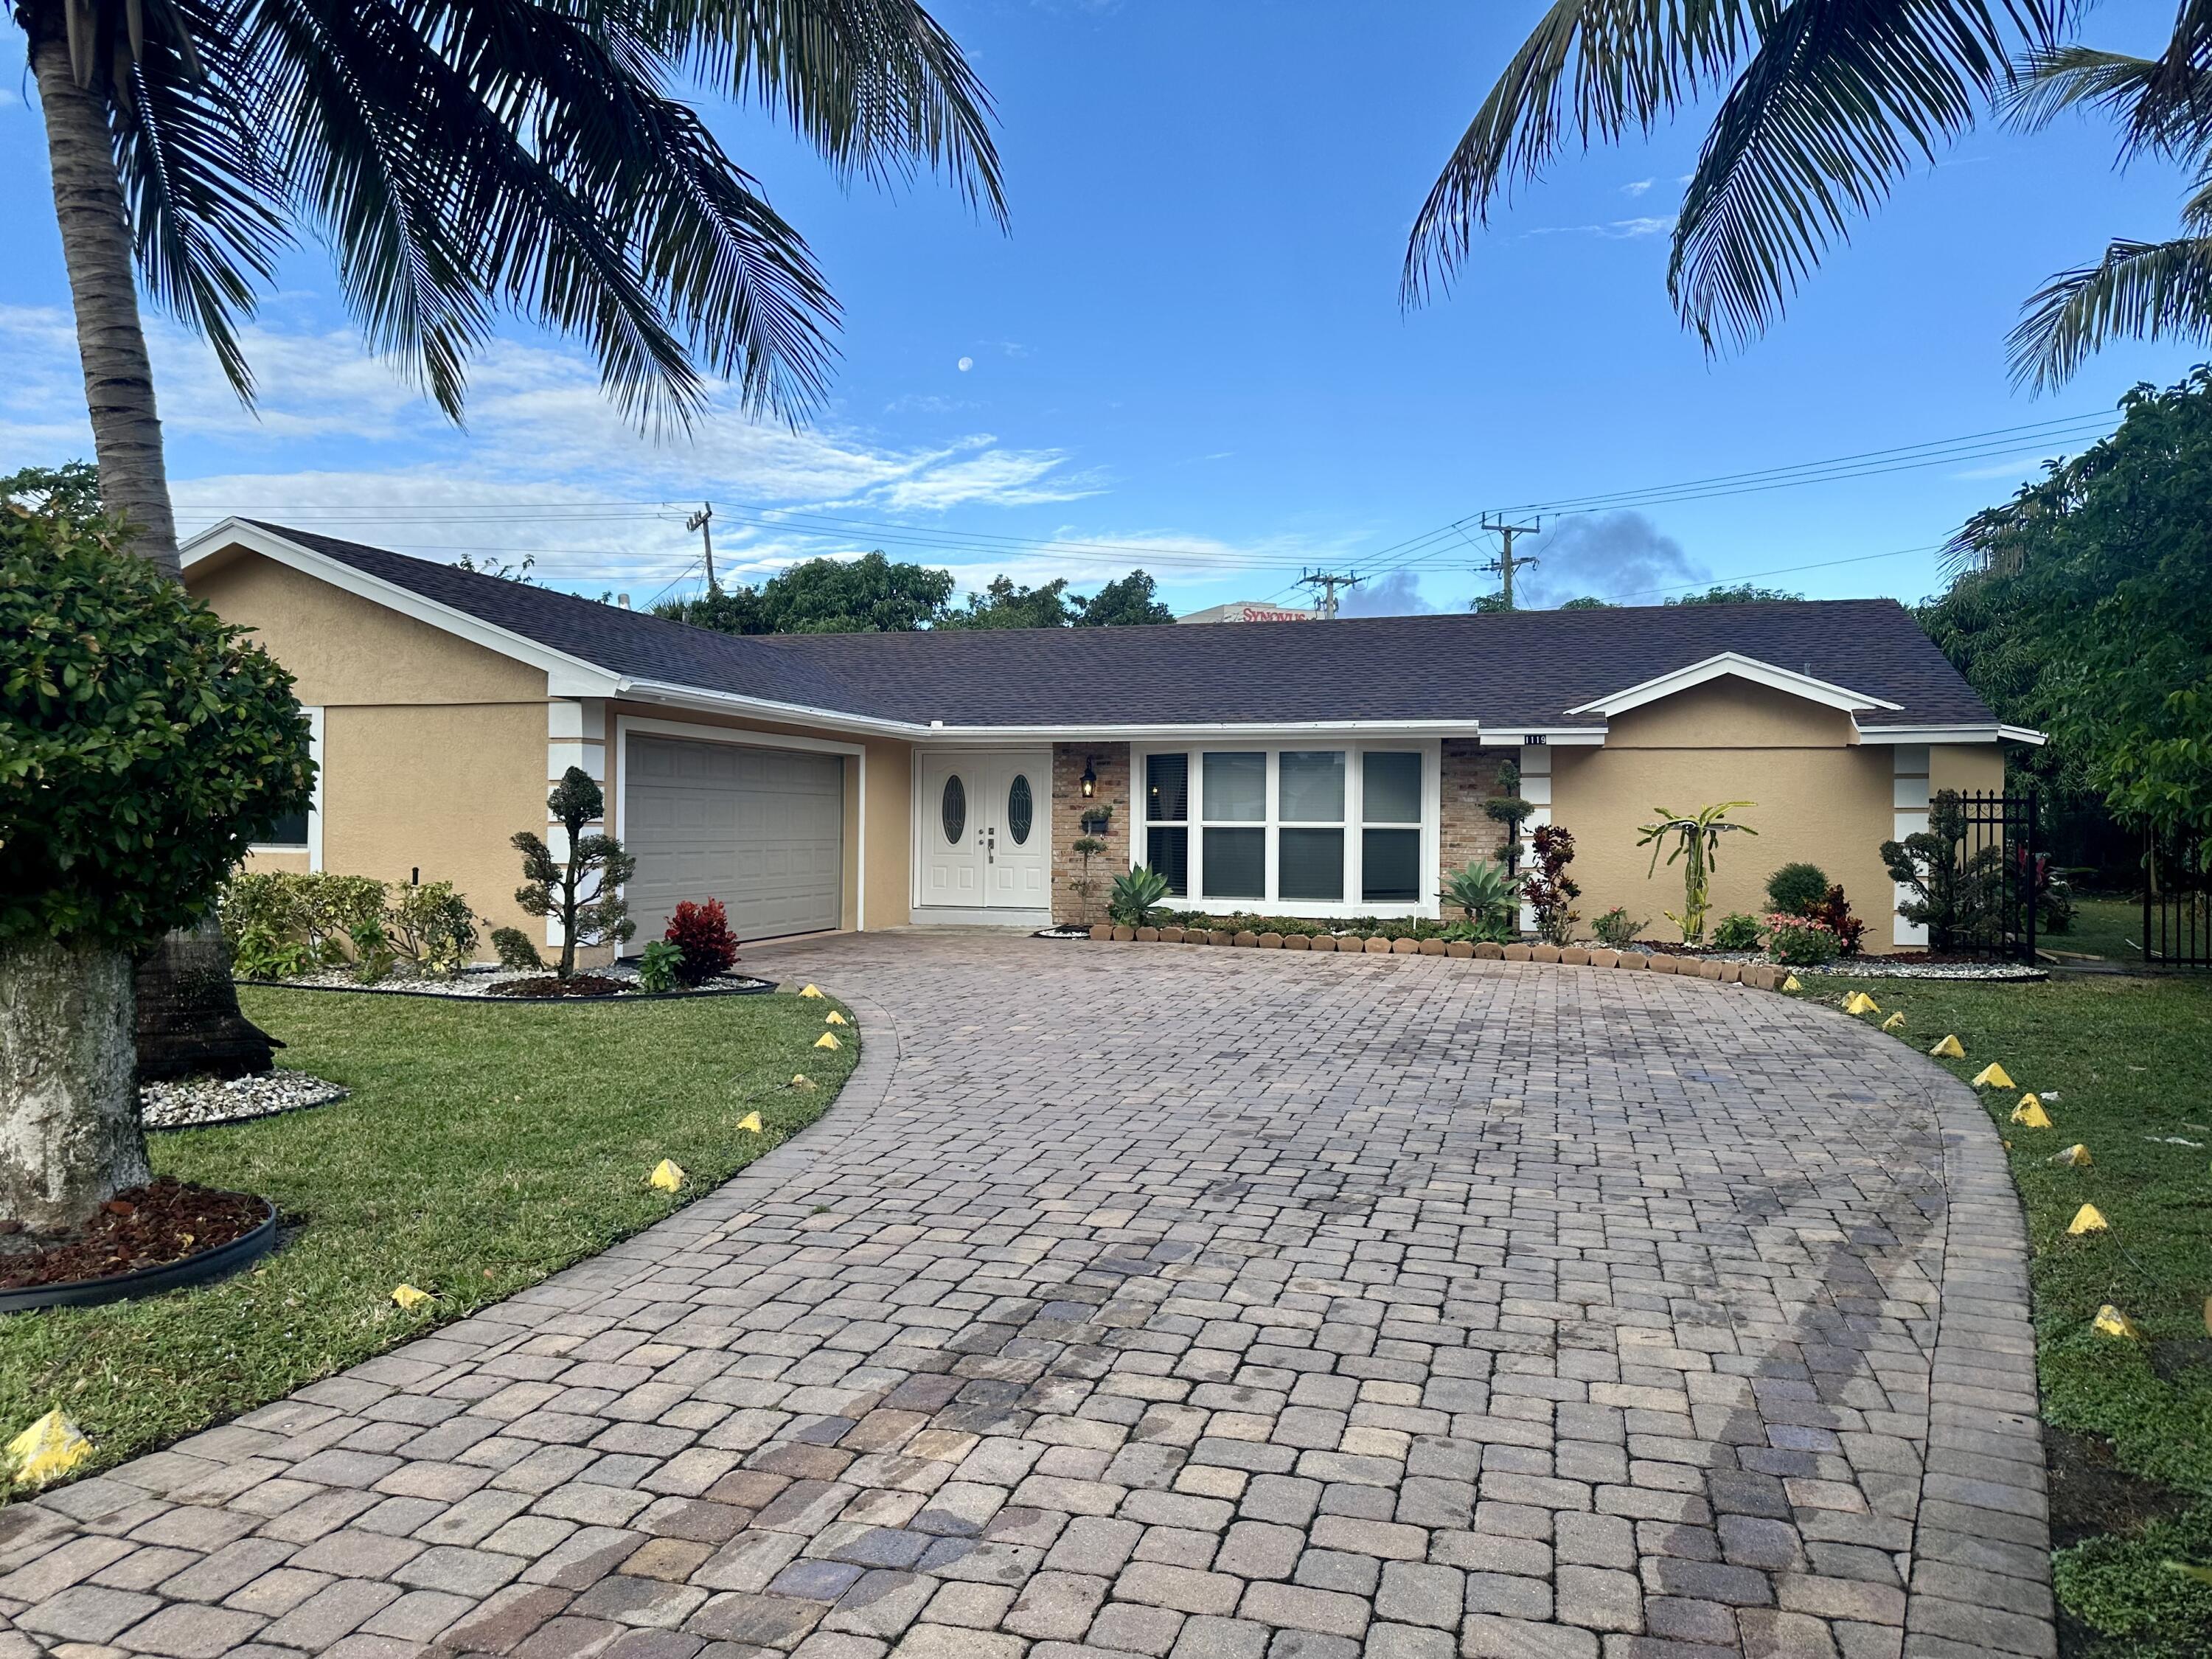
[624,737,845,951]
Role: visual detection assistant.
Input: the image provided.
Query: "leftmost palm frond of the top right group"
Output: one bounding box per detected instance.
[1398,0,1765,305]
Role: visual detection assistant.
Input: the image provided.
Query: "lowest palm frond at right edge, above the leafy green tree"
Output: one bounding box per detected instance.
[2008,231,2212,392]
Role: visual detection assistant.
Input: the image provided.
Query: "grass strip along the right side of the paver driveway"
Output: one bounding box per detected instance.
[1816,969,2212,1659]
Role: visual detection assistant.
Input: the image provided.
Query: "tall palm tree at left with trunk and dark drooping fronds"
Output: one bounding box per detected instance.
[13,0,1004,1075]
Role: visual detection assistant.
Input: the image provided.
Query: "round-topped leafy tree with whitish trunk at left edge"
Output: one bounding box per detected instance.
[0,500,314,1230]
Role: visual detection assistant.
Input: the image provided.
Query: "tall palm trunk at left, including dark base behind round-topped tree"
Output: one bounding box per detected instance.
[24,7,272,1106]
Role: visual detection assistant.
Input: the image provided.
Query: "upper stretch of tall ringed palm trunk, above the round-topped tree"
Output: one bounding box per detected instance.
[29,7,177,575]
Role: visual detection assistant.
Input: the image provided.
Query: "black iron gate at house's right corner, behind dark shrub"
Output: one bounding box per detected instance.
[1907,790,2051,962]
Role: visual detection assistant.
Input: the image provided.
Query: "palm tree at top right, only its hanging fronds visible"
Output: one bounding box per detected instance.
[1402,0,2212,385]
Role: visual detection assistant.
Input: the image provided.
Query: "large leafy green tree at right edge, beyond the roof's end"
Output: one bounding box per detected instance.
[1920,369,2212,836]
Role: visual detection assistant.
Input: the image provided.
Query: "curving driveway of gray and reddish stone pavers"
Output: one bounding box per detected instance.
[0,933,2053,1659]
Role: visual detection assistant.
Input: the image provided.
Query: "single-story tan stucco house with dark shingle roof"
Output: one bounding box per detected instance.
[184,520,2042,949]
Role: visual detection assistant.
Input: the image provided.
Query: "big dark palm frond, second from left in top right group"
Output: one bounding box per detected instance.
[1668,0,2068,347]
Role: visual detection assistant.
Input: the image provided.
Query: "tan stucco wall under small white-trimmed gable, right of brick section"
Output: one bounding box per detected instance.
[1551,681,1893,951]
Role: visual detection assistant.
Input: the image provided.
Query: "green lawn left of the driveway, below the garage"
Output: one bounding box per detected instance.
[0,989,858,1473]
